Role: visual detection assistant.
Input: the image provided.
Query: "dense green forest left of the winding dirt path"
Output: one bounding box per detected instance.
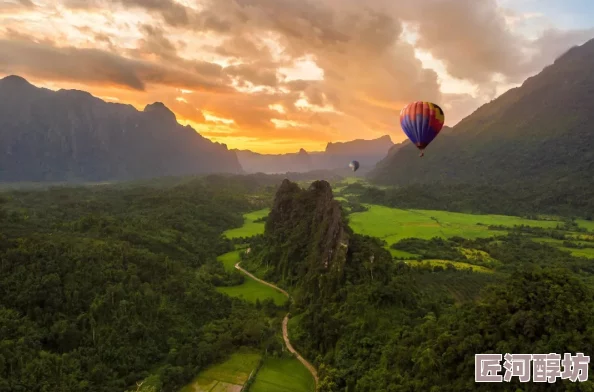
[0,176,274,392]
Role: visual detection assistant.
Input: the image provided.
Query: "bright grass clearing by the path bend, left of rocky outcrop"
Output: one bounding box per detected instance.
[217,250,287,305]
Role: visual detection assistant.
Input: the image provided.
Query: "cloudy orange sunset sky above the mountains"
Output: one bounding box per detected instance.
[0,0,594,153]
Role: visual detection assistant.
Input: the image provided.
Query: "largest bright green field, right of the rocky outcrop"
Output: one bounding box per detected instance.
[350,205,561,245]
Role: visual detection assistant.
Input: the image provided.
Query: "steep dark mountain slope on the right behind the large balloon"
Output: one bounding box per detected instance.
[370,40,594,193]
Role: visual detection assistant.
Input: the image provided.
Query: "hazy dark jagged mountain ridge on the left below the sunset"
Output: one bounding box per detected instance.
[0,76,241,182]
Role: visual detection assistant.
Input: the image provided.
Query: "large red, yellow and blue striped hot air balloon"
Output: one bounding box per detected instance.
[400,101,445,157]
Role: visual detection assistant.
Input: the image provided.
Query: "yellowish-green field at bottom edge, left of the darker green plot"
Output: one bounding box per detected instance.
[180,352,262,392]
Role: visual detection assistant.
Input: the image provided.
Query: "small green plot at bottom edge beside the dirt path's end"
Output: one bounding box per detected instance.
[250,358,315,392]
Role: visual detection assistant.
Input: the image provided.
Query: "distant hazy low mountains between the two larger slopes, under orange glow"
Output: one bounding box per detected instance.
[235,135,393,174]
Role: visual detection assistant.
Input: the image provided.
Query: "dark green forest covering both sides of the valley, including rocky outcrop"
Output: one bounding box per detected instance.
[0,175,594,392]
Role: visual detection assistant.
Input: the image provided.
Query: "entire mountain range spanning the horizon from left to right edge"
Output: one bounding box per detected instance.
[0,31,594,188]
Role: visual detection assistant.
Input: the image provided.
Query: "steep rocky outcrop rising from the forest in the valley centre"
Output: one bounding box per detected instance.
[261,180,351,303]
